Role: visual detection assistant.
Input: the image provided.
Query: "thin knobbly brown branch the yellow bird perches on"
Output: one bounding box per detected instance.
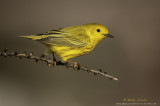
[0,48,118,81]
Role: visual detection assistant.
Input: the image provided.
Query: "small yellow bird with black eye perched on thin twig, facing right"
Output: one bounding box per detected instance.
[19,23,113,61]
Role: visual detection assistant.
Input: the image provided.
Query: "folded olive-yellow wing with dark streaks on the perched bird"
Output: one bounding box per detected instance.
[38,28,90,47]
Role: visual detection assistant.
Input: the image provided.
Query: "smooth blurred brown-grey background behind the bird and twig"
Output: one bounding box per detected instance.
[0,0,160,106]
